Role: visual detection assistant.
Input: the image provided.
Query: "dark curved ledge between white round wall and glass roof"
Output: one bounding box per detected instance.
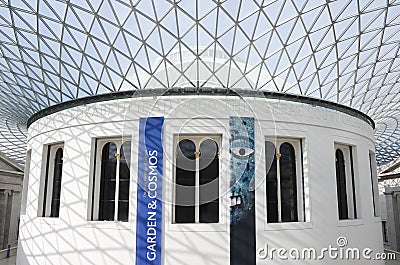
[27,87,375,129]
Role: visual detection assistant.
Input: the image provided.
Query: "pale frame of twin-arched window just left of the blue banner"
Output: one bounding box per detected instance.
[88,136,133,223]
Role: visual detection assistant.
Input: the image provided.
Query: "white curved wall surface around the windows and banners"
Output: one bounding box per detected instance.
[17,96,383,265]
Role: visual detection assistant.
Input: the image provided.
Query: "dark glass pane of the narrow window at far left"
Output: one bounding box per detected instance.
[50,148,63,217]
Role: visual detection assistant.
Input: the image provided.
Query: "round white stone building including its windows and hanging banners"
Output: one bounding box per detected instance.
[17,89,383,265]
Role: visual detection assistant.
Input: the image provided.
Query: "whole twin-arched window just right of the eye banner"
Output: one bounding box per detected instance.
[265,139,305,223]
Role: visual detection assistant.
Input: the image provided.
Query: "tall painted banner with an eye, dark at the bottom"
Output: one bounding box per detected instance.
[229,116,256,265]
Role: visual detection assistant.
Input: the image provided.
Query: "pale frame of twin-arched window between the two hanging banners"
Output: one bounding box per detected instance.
[172,133,222,225]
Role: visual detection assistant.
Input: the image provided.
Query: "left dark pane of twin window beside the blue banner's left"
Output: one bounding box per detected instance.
[99,142,117,221]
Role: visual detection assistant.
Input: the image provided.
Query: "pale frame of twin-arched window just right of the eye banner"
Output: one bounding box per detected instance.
[263,137,307,223]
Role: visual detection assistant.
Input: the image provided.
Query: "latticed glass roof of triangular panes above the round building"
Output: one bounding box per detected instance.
[0,0,400,164]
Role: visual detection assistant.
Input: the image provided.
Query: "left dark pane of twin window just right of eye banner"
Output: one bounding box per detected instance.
[265,141,278,223]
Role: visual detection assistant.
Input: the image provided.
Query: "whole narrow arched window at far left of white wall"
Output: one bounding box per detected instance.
[38,143,64,217]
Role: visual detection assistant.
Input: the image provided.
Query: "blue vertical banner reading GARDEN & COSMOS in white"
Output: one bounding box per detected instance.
[136,117,164,265]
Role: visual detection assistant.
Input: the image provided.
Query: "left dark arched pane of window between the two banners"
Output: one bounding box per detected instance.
[175,139,196,223]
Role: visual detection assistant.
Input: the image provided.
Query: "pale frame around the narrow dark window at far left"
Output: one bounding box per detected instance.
[38,142,65,218]
